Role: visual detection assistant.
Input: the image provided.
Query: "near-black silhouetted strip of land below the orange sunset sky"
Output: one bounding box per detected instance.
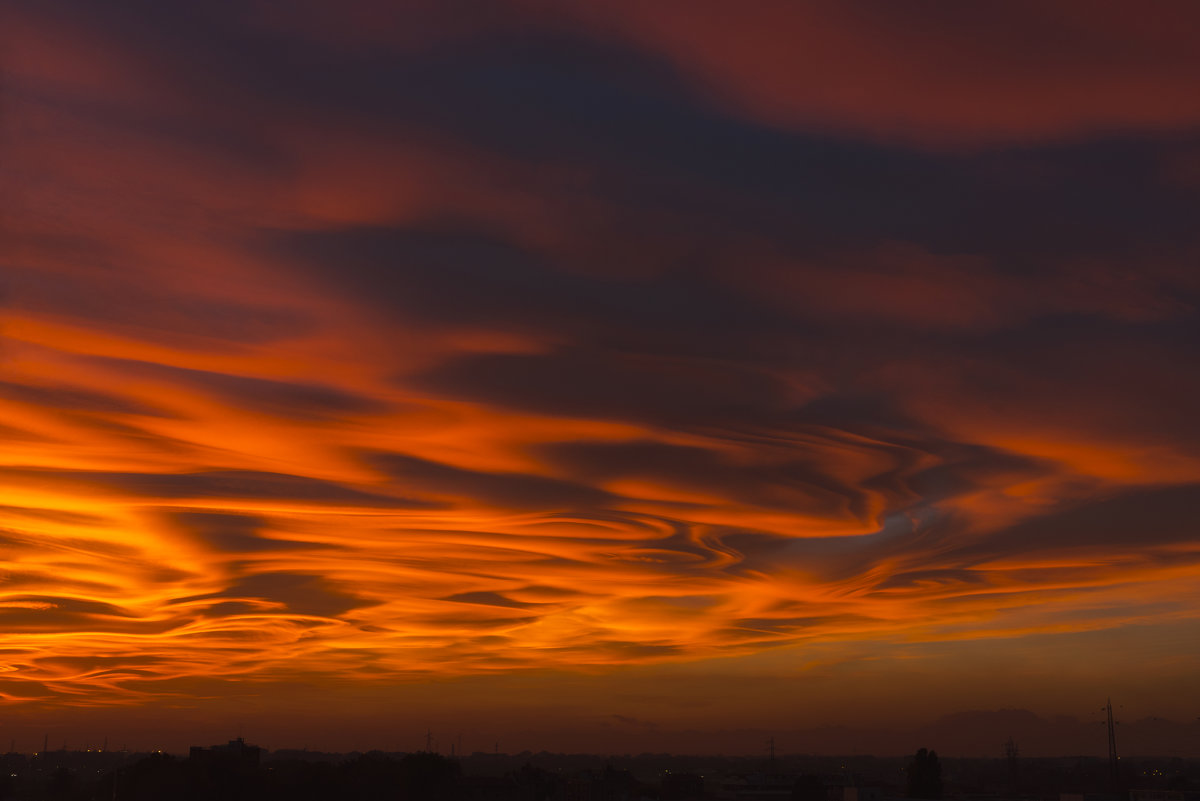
[0,740,1200,801]
